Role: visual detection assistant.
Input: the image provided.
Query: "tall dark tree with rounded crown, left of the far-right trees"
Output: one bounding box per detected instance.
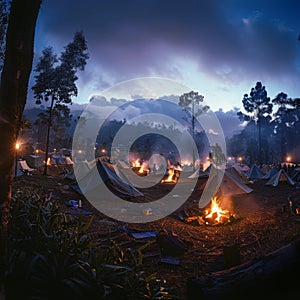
[237,82,273,162]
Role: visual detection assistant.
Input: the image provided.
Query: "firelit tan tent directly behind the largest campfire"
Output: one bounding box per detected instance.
[200,170,253,197]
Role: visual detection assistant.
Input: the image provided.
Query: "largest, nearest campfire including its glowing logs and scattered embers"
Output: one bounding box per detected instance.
[185,197,236,226]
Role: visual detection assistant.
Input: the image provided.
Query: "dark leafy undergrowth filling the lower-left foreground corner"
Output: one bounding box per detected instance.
[0,188,175,300]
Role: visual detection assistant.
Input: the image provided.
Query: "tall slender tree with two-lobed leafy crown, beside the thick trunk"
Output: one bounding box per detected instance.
[32,32,89,175]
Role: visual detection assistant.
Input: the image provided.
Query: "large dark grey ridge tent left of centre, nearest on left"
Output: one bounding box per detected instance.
[71,159,144,200]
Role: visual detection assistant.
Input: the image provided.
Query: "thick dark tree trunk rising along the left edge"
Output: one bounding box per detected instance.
[0,0,41,259]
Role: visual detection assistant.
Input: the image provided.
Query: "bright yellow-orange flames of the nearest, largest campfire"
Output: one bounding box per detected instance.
[204,197,231,225]
